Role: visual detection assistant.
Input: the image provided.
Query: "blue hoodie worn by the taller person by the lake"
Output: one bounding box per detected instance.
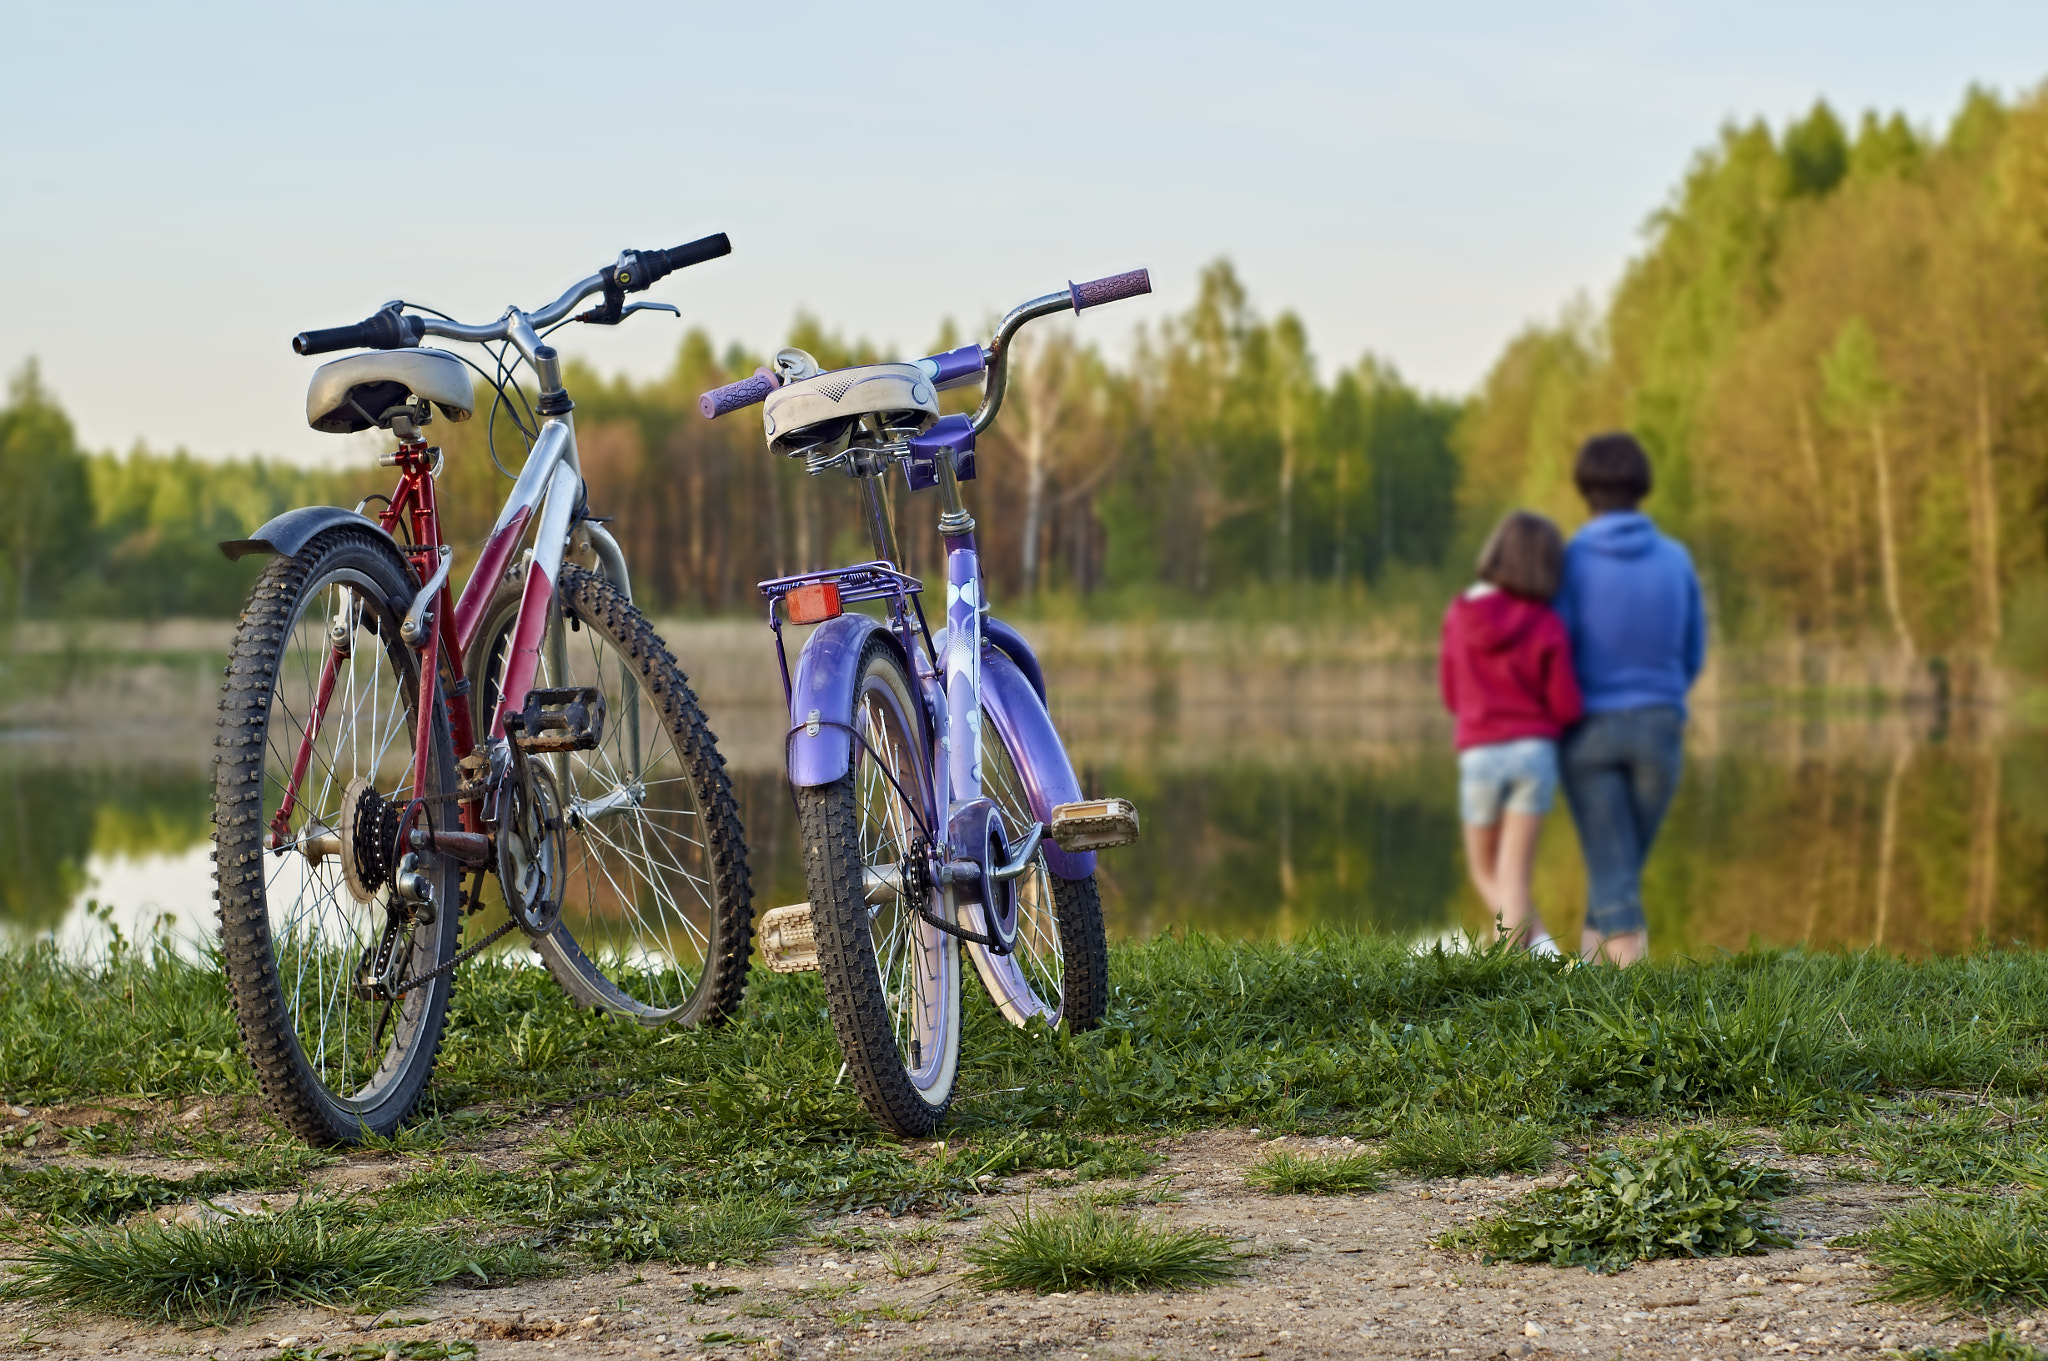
[1550,510,1706,714]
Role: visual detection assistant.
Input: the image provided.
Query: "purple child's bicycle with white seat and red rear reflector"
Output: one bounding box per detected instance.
[700,270,1151,1136]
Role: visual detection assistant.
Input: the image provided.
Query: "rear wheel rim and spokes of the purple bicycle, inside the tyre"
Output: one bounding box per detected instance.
[854,671,961,1097]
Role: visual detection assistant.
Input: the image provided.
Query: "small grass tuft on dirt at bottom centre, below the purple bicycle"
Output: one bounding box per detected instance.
[967,1199,1239,1293]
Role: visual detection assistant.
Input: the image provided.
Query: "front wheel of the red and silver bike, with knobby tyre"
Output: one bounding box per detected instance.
[469,565,754,1025]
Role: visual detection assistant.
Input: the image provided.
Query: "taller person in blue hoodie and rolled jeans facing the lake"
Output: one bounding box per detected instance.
[1550,434,1706,964]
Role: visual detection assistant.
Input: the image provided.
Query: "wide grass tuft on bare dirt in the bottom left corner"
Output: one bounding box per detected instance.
[0,1201,539,1322]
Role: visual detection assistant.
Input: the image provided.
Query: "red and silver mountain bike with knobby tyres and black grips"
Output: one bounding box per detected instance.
[215,233,752,1142]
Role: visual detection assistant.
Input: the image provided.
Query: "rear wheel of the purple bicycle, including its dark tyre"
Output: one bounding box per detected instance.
[797,636,961,1138]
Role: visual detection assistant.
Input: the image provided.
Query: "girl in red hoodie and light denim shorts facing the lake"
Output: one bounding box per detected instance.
[1438,510,1579,954]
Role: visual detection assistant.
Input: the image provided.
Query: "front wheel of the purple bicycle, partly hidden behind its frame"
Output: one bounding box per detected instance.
[967,708,1110,1031]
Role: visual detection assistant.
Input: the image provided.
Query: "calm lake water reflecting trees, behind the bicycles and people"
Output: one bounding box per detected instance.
[0,710,2048,954]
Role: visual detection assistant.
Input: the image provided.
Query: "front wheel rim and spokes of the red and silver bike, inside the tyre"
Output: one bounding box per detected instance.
[485,610,717,1023]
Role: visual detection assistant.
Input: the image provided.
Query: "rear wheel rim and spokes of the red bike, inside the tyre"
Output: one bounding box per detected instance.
[262,569,453,1109]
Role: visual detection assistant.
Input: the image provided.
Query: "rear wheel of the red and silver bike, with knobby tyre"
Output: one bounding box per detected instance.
[213,530,461,1144]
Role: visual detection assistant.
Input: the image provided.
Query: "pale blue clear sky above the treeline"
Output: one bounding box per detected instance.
[0,0,2048,460]
